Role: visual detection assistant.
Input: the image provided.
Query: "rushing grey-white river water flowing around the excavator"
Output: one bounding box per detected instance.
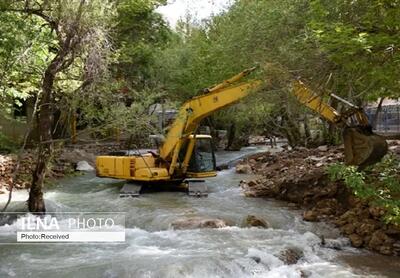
[0,147,400,278]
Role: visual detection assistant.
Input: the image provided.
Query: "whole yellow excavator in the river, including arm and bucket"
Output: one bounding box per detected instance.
[96,68,387,197]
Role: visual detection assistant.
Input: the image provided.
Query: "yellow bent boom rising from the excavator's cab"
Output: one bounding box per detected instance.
[160,68,262,163]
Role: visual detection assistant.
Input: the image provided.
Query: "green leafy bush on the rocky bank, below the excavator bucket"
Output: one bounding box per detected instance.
[327,156,400,225]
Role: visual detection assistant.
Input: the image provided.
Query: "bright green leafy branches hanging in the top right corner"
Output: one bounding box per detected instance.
[308,0,400,100]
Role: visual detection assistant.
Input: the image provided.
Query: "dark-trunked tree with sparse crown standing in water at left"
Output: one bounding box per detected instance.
[1,0,113,213]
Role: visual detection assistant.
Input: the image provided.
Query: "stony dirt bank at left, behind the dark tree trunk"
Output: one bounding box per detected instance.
[0,144,120,194]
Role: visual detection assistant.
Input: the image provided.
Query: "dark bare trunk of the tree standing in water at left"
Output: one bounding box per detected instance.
[28,60,61,214]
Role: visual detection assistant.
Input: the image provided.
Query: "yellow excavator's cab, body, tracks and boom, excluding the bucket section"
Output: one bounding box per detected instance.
[96,68,262,197]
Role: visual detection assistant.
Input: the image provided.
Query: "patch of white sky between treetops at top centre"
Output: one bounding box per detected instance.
[157,0,232,27]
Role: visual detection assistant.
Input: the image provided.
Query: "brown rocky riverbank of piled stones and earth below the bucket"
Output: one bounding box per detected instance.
[236,142,400,255]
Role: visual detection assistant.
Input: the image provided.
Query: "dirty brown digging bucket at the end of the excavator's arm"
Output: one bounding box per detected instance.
[342,126,388,169]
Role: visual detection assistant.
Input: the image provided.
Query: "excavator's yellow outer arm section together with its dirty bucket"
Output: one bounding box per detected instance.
[293,80,388,169]
